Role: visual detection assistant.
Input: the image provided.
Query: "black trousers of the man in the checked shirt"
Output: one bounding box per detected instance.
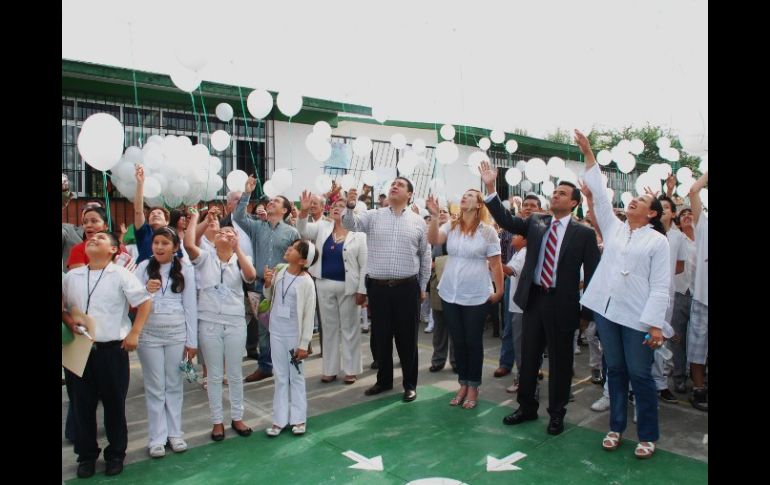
[366,280,420,390]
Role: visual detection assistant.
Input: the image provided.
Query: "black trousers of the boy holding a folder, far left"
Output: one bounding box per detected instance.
[64,343,130,462]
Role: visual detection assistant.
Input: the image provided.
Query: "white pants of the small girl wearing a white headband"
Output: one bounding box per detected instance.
[270,330,306,428]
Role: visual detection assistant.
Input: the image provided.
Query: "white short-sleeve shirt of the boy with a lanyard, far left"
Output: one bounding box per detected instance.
[62,263,150,342]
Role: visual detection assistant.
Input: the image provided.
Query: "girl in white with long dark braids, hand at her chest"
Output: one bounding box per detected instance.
[136,226,198,458]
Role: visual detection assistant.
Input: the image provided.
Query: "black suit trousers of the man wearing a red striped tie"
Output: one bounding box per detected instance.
[517,285,579,417]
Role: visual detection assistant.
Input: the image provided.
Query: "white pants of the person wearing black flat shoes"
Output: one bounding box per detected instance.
[198,320,246,424]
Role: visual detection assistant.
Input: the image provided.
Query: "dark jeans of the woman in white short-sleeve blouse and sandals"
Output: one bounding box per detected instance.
[441,299,490,387]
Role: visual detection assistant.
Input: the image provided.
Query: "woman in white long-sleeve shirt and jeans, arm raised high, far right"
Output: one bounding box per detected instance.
[575,130,673,458]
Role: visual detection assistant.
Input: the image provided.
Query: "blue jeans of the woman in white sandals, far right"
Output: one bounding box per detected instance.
[594,313,659,441]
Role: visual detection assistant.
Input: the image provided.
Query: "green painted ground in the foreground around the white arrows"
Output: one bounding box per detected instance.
[67,386,708,485]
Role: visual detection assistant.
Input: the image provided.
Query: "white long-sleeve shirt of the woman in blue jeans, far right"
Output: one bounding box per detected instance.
[580,165,674,338]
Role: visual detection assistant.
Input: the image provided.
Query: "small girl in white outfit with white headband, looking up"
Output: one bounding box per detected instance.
[264,240,318,436]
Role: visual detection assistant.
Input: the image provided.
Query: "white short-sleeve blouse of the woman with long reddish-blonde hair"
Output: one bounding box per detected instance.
[438,222,501,306]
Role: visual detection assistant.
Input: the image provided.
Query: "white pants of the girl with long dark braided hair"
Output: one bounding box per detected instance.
[136,342,184,448]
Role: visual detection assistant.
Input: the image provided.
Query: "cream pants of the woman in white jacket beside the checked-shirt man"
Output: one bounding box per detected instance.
[316,278,363,376]
